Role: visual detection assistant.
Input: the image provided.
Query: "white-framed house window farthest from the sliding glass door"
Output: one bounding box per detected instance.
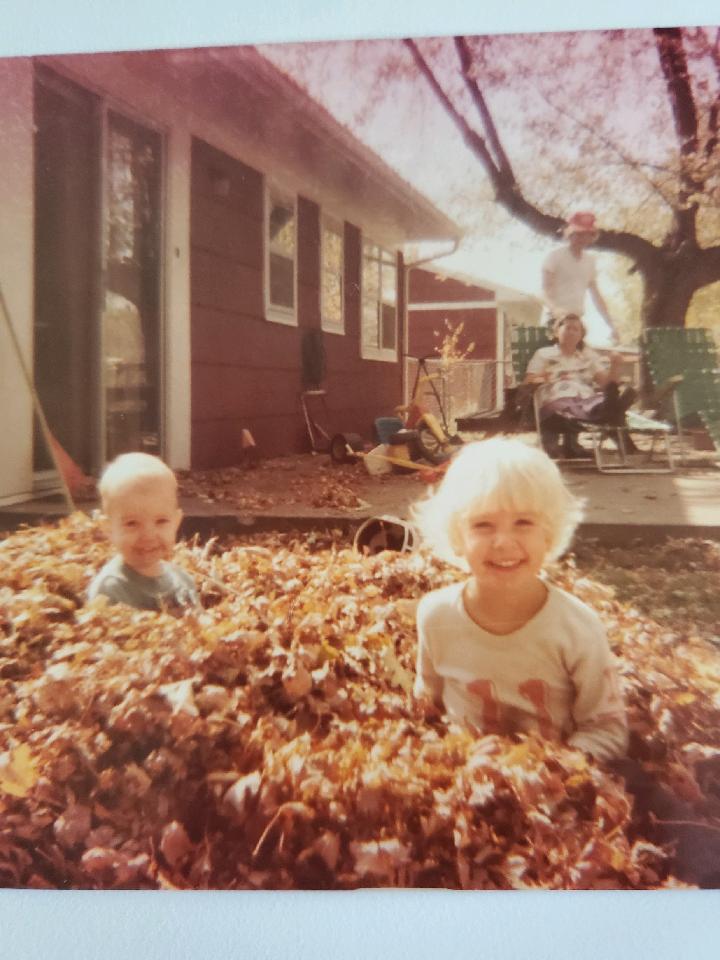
[361,240,397,361]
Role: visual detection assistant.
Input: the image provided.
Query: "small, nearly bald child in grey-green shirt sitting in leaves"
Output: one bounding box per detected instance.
[88,453,198,612]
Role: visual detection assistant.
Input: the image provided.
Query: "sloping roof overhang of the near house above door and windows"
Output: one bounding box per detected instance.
[36,47,462,248]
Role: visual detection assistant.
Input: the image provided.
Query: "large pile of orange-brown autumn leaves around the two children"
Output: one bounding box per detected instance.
[0,515,720,889]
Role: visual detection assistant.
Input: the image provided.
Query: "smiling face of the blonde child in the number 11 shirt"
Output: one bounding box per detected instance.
[460,510,550,592]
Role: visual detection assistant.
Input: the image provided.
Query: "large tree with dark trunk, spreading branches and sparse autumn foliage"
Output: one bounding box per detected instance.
[404,28,720,326]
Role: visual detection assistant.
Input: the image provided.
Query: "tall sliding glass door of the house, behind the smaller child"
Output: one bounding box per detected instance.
[34,68,162,473]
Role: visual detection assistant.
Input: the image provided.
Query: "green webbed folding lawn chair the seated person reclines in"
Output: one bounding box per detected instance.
[511,327,675,473]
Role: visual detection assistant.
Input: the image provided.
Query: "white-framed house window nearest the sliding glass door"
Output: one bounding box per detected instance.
[265,189,297,325]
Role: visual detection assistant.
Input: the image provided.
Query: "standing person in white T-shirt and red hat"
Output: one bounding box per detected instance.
[543,211,618,342]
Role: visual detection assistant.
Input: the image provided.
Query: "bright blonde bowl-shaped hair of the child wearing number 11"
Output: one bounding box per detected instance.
[412,437,583,567]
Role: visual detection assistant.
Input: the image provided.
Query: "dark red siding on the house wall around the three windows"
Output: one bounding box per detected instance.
[190,140,403,468]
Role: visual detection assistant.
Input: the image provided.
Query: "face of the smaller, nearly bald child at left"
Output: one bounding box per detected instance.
[107,482,182,577]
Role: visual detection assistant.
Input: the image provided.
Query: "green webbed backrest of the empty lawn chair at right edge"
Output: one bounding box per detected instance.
[641,327,720,451]
